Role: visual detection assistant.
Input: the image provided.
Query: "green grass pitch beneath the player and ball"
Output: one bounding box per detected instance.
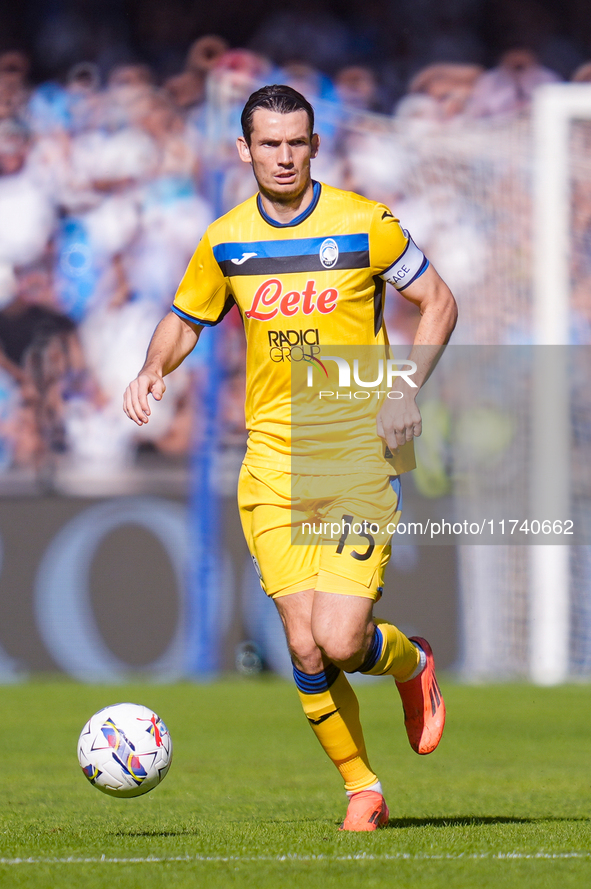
[0,676,591,889]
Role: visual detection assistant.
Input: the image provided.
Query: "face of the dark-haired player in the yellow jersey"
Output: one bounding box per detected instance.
[237,108,320,204]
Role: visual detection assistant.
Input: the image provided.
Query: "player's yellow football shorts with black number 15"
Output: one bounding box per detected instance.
[238,465,402,601]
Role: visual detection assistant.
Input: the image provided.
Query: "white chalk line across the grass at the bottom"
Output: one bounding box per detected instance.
[0,852,591,866]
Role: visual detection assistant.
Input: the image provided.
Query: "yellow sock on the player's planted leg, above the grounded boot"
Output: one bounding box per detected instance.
[294,664,378,793]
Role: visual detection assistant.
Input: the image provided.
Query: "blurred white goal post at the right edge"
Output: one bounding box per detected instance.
[529,84,591,685]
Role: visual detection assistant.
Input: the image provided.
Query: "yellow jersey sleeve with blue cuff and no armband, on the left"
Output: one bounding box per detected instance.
[172,232,234,327]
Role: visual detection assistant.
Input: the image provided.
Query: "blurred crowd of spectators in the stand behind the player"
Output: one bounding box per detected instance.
[0,0,591,484]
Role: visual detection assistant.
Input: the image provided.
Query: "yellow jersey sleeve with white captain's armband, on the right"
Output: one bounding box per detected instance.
[369,204,429,290]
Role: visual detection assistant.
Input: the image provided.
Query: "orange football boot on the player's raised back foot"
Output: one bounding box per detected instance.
[396,636,445,754]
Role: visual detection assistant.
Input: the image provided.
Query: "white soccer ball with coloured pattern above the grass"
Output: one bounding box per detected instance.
[78,704,172,797]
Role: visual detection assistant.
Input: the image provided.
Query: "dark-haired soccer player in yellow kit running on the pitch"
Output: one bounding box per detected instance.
[124,85,456,831]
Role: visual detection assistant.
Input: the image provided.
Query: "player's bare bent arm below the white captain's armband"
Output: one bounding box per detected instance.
[377,265,458,450]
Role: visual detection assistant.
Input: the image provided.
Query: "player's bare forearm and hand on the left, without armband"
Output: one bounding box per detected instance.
[123,312,203,426]
